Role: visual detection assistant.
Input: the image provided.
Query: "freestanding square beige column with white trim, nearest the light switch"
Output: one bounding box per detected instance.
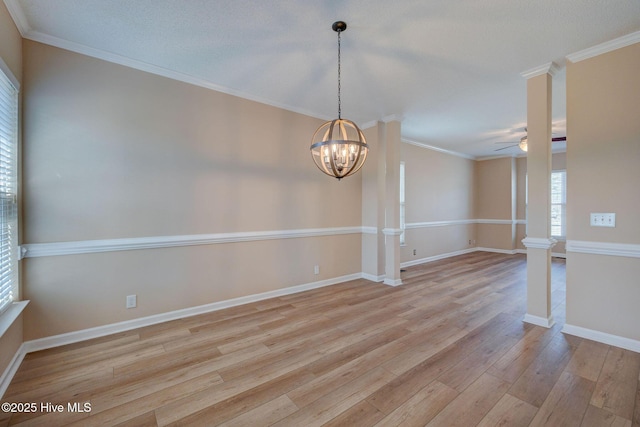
[522,63,557,328]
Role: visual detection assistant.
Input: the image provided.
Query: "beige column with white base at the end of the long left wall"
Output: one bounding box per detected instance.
[382,118,402,286]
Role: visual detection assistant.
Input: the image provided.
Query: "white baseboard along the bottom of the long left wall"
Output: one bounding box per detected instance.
[23,273,362,353]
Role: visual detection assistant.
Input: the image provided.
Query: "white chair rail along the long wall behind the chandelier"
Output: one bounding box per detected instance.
[20,227,364,258]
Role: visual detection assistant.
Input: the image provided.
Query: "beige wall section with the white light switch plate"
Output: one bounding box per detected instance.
[567,44,640,340]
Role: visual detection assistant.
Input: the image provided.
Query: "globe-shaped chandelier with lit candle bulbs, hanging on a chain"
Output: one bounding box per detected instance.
[311,21,369,180]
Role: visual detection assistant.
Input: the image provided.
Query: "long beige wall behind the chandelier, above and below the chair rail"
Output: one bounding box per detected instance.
[24,41,362,339]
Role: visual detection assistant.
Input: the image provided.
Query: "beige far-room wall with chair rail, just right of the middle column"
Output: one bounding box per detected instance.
[400,143,476,263]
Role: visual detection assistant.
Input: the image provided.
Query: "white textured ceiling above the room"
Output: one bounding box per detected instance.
[5,0,640,157]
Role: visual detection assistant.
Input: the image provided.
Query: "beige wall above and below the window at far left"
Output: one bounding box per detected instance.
[0,2,24,388]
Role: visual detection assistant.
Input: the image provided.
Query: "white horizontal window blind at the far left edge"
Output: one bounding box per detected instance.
[0,63,18,313]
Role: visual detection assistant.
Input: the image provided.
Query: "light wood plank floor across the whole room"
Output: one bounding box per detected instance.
[0,252,640,427]
